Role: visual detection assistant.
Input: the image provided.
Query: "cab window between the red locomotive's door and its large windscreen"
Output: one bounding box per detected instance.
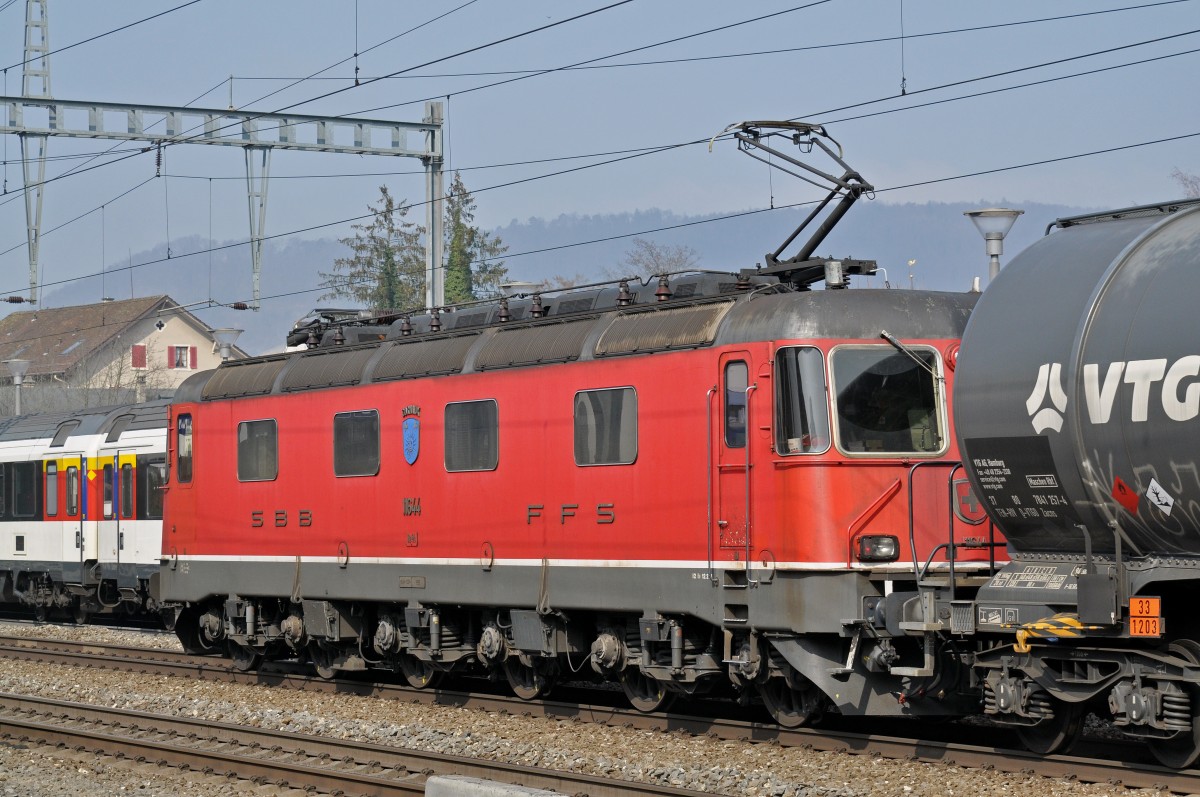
[775,346,832,455]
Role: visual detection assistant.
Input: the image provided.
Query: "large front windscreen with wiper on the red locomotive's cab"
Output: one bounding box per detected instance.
[830,346,944,454]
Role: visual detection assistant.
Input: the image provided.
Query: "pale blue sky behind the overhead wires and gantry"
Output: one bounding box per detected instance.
[0,0,1200,309]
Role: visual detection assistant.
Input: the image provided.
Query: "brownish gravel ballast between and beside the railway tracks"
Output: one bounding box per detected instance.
[0,623,1166,797]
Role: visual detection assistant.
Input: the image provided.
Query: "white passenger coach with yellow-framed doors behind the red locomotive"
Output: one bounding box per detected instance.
[0,401,167,622]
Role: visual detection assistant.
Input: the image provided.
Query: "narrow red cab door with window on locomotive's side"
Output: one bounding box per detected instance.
[709,352,754,562]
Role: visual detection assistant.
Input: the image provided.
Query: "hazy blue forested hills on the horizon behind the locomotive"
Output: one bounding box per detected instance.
[42,200,1084,354]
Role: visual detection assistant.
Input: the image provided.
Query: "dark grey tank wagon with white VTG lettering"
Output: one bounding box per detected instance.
[955,202,1200,767]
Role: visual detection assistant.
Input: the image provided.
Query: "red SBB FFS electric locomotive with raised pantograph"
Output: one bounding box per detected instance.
[161,125,998,725]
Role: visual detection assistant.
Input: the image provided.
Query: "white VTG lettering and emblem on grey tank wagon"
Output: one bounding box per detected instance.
[1025,354,1200,435]
